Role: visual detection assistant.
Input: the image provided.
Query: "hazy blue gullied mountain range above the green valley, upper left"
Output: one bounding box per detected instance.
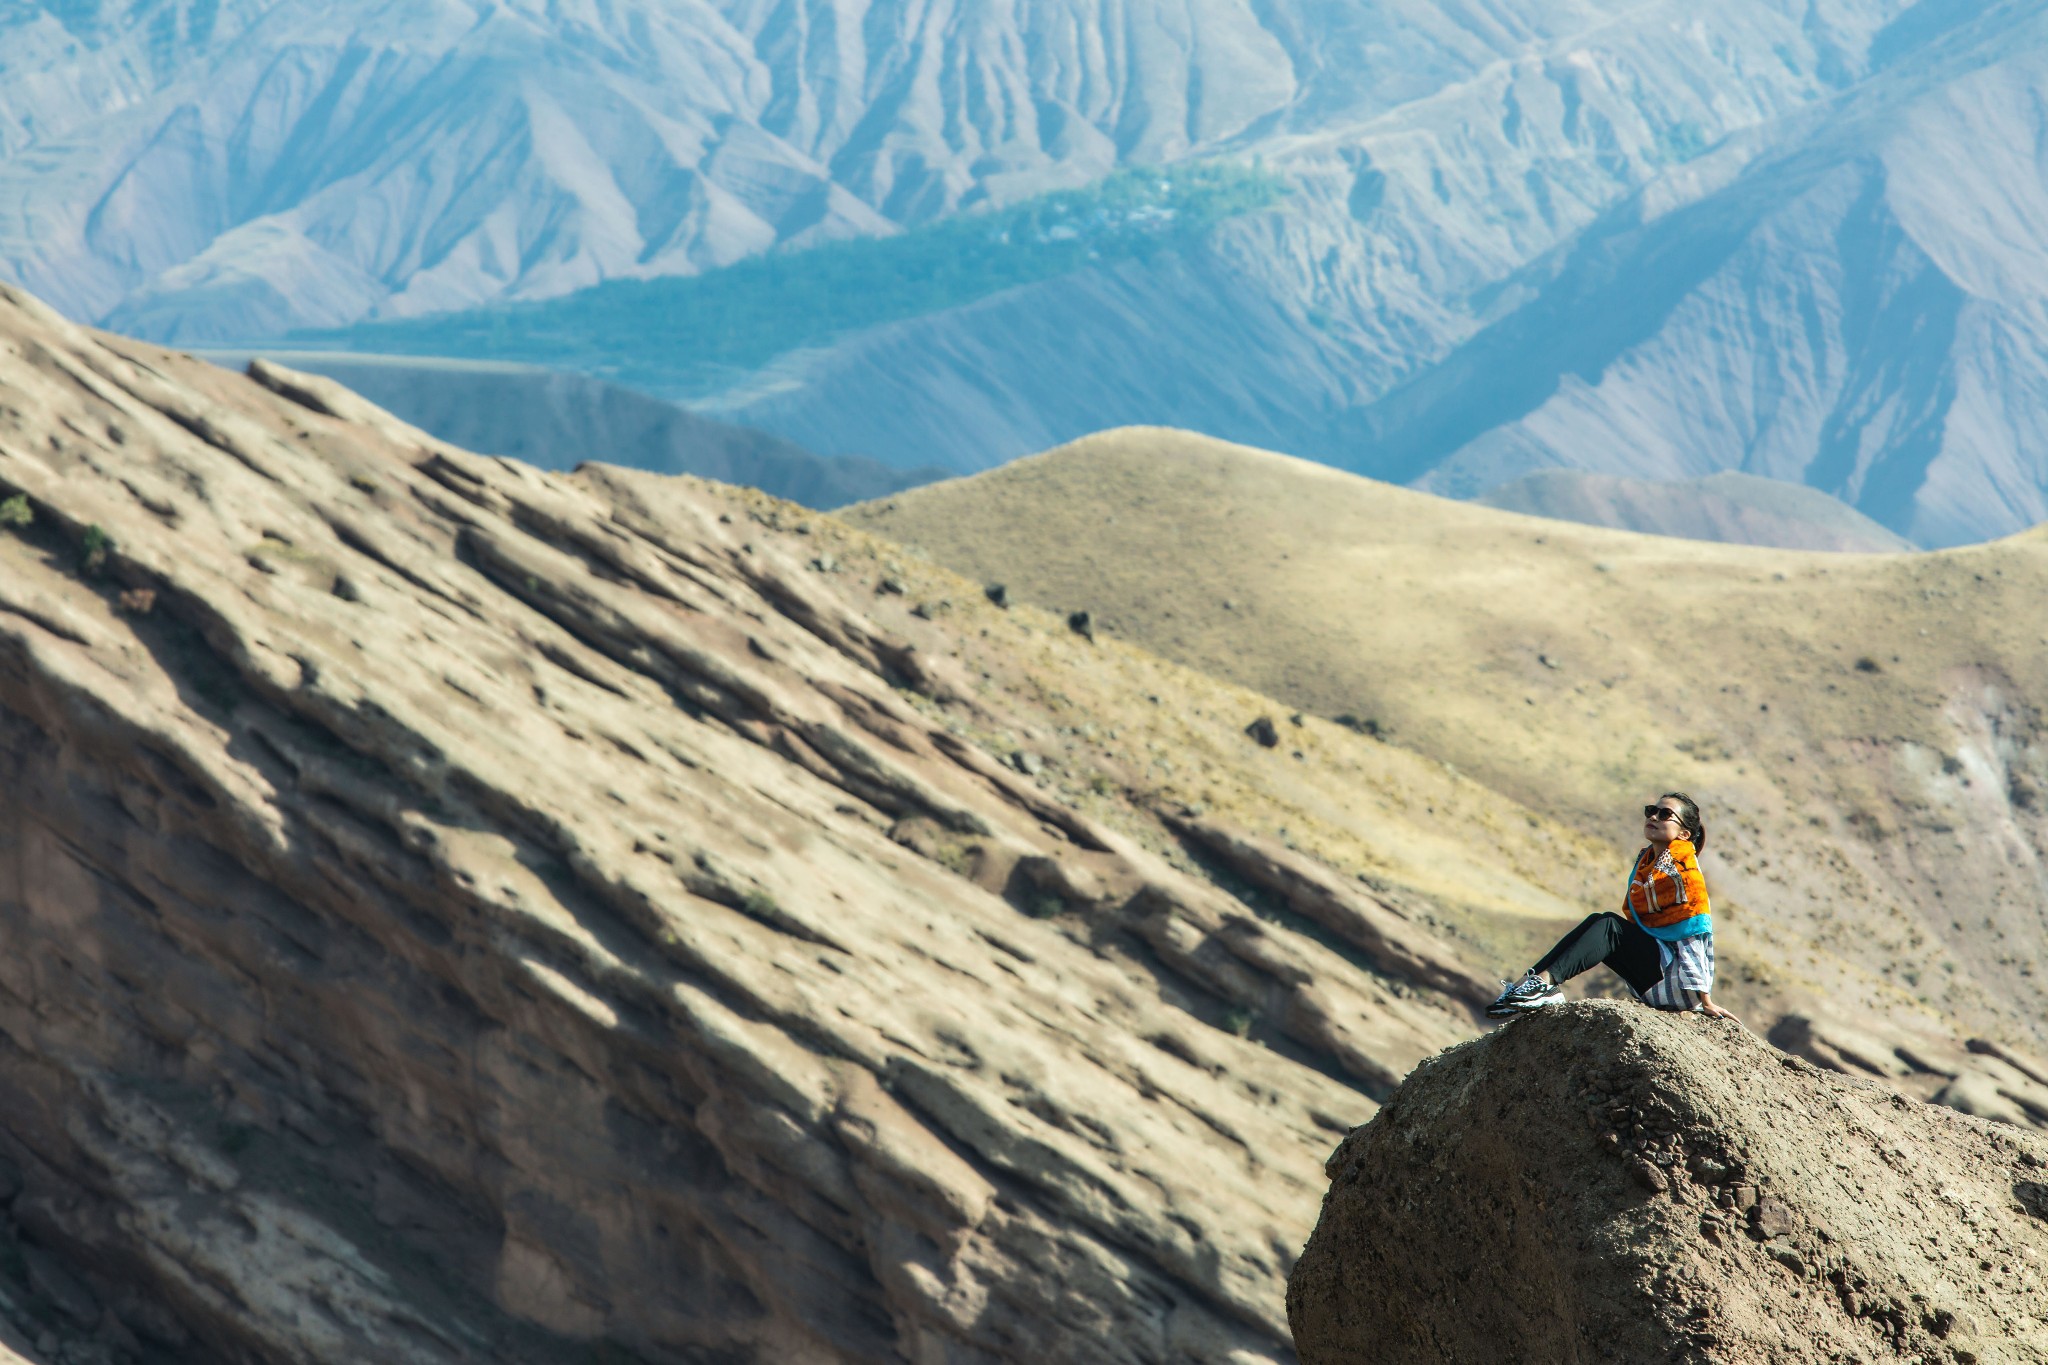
[0,0,1425,340]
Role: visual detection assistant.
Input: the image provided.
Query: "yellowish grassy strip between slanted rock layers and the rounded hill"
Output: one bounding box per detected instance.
[707,485,1606,986]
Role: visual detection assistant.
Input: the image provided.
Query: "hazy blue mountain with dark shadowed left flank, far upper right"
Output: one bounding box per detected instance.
[1392,4,2048,546]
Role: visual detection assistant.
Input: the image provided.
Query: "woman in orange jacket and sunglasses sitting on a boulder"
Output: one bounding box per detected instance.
[1487,792,1735,1019]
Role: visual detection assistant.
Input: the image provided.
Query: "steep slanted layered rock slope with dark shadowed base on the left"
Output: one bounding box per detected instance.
[0,293,1507,1363]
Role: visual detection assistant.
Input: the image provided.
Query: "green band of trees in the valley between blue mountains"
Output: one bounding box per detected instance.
[289,162,1284,397]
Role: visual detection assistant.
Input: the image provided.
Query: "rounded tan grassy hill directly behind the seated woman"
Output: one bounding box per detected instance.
[844,430,2048,1117]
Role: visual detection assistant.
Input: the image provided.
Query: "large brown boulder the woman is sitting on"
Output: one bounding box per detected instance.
[1288,1003,2048,1365]
